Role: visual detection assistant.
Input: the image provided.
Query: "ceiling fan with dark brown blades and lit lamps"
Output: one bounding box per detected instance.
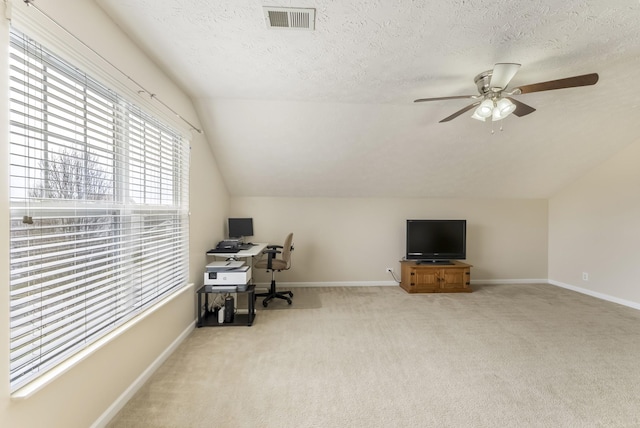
[414,63,598,123]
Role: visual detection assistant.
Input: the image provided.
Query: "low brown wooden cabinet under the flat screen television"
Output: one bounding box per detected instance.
[400,260,473,293]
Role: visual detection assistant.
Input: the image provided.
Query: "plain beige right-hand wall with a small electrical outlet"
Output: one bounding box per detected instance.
[549,141,640,308]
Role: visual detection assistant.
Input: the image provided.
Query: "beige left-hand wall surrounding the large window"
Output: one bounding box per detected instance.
[0,0,228,428]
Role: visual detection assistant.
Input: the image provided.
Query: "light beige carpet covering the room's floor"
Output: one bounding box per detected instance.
[109,284,640,428]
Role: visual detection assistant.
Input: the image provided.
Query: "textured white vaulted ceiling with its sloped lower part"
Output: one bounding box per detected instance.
[96,0,640,198]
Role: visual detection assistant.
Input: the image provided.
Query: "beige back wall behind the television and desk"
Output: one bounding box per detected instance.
[230,197,547,285]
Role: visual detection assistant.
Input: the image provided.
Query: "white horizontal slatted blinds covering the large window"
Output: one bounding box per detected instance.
[9,29,189,390]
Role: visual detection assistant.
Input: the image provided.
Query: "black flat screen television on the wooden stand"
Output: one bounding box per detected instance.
[405,220,467,263]
